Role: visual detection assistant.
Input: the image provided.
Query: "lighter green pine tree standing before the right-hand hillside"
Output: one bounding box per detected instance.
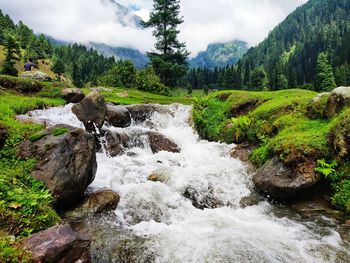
[316,52,337,91]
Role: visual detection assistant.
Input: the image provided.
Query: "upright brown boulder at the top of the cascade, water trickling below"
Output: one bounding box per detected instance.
[72,91,107,133]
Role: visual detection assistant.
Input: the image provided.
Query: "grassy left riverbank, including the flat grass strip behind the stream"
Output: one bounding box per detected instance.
[0,75,200,262]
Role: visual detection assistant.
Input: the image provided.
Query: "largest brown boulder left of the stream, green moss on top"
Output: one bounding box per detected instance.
[17,125,97,207]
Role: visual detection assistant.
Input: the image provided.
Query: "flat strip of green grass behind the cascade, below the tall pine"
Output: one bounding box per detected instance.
[83,88,202,105]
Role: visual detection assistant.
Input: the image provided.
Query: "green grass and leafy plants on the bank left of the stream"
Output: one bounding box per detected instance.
[0,92,64,262]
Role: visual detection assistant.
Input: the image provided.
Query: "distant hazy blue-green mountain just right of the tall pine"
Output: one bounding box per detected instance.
[189,40,248,69]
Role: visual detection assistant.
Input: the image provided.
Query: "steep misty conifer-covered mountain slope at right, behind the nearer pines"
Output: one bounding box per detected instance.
[237,0,350,89]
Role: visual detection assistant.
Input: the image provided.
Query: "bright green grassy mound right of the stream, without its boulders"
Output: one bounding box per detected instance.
[193,89,350,212]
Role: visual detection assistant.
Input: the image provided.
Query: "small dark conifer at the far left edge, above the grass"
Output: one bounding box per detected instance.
[1,34,20,76]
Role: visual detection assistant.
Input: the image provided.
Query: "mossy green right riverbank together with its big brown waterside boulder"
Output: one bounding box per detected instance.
[193,90,350,212]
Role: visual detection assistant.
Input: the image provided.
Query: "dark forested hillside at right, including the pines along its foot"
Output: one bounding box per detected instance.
[182,0,350,91]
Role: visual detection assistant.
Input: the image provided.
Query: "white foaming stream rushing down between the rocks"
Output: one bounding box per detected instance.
[31,105,350,263]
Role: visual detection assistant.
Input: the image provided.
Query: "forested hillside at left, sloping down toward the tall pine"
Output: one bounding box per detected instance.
[0,10,115,87]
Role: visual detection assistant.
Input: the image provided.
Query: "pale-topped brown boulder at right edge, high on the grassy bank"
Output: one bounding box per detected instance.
[325,87,350,118]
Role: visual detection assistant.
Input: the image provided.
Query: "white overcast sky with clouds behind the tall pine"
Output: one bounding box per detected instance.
[0,0,307,56]
